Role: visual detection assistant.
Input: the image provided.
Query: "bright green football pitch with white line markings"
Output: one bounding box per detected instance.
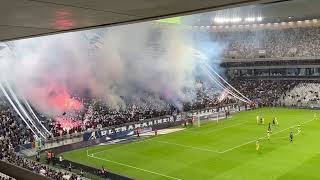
[63,108,320,180]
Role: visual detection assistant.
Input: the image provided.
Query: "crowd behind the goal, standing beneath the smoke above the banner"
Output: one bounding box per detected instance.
[48,81,236,136]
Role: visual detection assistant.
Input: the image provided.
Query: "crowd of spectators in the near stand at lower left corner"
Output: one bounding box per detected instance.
[0,104,79,180]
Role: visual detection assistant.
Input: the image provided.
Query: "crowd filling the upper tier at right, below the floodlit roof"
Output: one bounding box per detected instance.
[212,27,320,59]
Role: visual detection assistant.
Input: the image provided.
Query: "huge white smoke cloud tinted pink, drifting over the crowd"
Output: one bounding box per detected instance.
[0,23,222,114]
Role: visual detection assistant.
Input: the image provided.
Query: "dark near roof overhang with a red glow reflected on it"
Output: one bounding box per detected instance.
[0,0,272,41]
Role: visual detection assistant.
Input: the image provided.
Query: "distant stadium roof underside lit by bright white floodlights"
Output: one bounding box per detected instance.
[193,0,320,26]
